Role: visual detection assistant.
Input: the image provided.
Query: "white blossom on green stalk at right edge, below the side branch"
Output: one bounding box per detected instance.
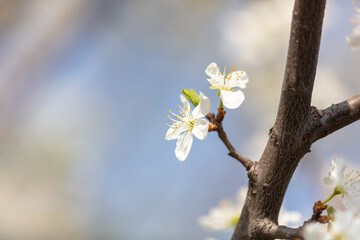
[324,157,360,211]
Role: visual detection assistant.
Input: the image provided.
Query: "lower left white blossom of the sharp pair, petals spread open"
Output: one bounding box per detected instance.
[165,92,211,161]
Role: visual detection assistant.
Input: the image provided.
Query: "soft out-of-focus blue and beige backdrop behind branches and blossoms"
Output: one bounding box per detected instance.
[0,0,360,240]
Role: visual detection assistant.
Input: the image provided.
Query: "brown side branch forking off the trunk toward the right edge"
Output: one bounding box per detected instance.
[308,94,360,143]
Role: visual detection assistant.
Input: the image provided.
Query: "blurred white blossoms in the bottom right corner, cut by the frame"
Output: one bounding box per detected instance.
[304,211,360,240]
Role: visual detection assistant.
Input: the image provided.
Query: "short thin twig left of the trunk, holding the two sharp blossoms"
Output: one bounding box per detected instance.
[206,108,254,171]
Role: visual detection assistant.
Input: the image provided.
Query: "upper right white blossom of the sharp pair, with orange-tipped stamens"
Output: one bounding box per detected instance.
[205,63,249,109]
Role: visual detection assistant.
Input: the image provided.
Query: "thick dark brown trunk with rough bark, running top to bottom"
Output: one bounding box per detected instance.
[232,0,326,240]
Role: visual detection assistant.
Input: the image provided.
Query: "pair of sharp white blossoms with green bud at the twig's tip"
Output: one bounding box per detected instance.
[165,63,249,161]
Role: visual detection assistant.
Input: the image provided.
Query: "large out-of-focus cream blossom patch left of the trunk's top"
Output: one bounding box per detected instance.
[221,0,293,66]
